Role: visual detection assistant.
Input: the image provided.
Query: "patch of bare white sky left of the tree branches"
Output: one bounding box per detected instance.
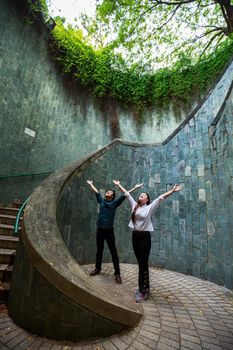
[47,0,96,24]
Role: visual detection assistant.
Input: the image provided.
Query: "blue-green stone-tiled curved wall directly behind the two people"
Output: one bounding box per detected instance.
[58,66,233,288]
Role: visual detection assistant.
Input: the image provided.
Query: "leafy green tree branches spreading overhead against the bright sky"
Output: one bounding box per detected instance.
[79,0,233,65]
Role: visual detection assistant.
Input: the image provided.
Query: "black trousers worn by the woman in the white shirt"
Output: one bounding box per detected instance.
[132,231,151,293]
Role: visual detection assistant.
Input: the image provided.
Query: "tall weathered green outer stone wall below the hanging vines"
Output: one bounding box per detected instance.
[0,0,229,202]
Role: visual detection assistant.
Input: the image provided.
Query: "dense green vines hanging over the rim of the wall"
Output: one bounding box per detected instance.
[52,21,233,111]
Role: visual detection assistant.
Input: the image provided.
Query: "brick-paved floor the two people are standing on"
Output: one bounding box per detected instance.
[0,264,233,350]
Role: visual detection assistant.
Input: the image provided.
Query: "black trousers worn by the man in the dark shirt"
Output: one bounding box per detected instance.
[95,227,120,276]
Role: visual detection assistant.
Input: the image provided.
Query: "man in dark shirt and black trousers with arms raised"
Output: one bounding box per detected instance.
[87,180,142,283]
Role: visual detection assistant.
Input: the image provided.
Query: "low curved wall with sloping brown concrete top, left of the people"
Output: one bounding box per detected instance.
[8,145,142,341]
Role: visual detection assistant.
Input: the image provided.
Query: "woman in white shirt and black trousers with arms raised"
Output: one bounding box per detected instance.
[113,180,182,303]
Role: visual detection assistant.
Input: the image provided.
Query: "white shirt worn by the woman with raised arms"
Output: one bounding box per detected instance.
[125,192,164,231]
